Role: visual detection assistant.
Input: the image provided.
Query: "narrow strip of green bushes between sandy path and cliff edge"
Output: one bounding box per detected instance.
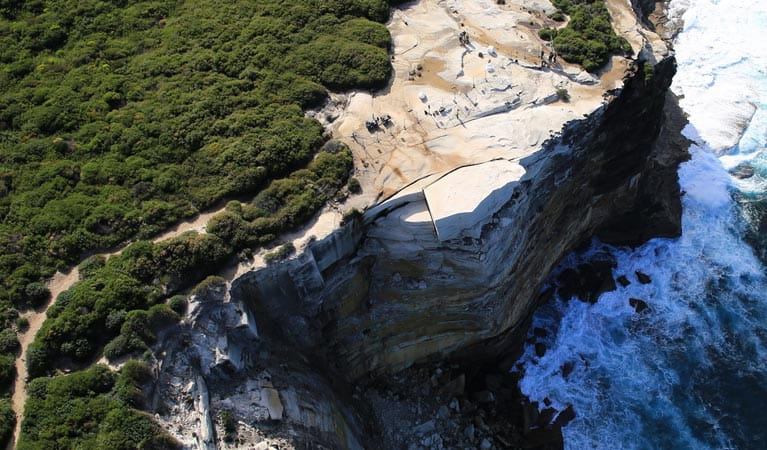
[25,145,352,377]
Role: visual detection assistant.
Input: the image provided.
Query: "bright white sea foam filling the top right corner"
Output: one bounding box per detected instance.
[671,0,767,152]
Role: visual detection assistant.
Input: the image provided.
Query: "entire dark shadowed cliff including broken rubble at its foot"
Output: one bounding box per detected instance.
[148,1,687,449]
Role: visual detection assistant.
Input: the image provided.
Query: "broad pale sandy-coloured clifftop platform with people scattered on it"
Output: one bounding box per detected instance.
[324,0,633,201]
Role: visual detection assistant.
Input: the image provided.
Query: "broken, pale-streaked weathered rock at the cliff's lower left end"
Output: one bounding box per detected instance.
[152,285,370,449]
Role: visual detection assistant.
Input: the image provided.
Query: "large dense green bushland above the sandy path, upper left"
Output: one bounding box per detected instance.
[0,0,391,358]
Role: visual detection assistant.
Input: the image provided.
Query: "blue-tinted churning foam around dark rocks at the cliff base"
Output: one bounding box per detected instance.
[520,142,767,449]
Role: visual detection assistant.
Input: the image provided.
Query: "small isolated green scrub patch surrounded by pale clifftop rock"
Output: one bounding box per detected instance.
[538,0,631,72]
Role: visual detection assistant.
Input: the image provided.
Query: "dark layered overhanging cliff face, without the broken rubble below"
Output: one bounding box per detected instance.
[231,57,686,380]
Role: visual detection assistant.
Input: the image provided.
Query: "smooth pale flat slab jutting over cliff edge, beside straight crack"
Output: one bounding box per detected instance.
[423,159,525,241]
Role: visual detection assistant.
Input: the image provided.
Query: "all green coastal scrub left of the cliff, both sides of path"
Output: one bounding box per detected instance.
[0,0,394,448]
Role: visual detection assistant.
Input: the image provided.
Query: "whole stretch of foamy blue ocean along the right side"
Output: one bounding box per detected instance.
[520,0,767,449]
